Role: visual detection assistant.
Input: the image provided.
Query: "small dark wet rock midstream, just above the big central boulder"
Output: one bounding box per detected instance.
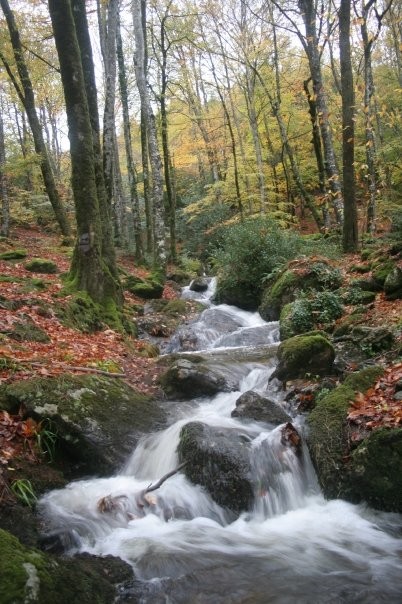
[231,390,291,426]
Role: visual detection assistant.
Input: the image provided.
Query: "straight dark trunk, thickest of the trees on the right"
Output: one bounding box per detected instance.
[339,0,358,252]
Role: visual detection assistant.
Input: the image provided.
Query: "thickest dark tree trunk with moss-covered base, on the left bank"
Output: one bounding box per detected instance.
[48,0,122,312]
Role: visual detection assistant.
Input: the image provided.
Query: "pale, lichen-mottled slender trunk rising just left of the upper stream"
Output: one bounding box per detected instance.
[132,0,167,268]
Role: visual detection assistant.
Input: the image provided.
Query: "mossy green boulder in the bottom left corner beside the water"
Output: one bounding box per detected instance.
[0,529,132,604]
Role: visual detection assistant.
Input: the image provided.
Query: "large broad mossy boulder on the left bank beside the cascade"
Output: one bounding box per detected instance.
[0,374,165,476]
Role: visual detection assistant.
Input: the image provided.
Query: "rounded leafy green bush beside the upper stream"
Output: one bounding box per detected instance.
[215,218,301,309]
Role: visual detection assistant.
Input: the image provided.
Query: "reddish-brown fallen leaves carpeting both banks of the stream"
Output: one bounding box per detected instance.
[0,227,402,501]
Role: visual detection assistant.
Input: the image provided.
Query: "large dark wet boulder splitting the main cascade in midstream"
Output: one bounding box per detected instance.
[178,422,254,513]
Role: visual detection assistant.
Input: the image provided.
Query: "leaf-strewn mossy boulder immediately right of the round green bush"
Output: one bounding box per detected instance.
[259,259,342,321]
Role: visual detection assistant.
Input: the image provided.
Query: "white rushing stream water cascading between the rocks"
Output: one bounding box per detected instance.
[41,285,402,604]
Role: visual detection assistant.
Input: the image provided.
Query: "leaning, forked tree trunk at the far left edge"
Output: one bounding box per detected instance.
[0,0,70,236]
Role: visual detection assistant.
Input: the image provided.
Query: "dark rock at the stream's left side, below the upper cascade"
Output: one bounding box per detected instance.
[159,359,235,399]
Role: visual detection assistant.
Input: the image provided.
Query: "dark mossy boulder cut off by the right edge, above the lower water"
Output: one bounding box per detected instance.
[347,428,402,512]
